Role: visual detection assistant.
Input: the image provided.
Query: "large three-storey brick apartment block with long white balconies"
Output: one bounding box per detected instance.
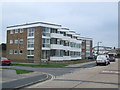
[7,22,92,63]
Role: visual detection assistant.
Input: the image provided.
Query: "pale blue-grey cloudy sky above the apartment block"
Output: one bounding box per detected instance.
[0,2,118,47]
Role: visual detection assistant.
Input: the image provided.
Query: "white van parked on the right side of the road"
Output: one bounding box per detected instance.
[96,55,110,65]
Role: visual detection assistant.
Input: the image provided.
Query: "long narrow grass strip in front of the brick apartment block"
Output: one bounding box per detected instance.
[12,64,68,67]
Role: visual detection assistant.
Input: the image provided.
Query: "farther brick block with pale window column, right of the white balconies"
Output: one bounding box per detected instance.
[80,37,93,58]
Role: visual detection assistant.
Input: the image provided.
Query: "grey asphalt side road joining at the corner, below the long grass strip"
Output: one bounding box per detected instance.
[4,62,96,76]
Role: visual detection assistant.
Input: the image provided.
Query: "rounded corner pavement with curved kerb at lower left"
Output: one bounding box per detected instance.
[2,72,52,89]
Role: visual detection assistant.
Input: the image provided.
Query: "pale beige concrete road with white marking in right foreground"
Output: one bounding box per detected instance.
[26,59,120,89]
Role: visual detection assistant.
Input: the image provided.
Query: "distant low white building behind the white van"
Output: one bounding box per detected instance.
[93,46,112,55]
